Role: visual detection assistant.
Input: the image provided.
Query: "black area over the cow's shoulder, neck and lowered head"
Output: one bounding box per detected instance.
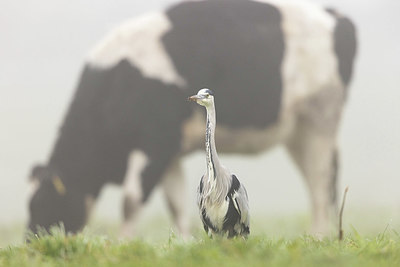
[30,60,192,231]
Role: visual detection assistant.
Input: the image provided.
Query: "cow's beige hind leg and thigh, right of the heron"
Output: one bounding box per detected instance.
[286,86,344,236]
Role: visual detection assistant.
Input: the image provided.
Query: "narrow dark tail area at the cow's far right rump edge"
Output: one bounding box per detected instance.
[326,8,357,97]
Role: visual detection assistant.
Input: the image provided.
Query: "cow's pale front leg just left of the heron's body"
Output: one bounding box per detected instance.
[162,160,189,238]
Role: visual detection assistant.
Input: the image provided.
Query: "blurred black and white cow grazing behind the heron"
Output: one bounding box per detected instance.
[29,0,356,239]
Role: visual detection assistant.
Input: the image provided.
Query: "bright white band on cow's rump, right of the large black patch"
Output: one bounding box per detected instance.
[259,0,339,112]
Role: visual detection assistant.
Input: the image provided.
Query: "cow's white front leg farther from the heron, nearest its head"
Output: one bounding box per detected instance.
[120,150,149,238]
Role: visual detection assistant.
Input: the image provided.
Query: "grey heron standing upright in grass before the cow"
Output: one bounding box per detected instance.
[189,88,250,238]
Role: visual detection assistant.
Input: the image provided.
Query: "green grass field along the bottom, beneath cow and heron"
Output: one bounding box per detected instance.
[0,210,400,267]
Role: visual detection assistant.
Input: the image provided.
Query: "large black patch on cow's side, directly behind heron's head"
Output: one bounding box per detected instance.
[162,0,284,128]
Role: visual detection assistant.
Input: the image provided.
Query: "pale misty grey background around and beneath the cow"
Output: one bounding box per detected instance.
[0,0,400,238]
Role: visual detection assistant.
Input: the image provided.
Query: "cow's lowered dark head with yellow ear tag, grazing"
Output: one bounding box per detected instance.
[28,166,86,232]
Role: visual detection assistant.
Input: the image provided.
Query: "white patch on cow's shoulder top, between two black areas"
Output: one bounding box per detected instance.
[88,12,186,87]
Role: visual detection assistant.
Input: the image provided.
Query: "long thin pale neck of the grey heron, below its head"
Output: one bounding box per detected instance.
[206,103,220,179]
